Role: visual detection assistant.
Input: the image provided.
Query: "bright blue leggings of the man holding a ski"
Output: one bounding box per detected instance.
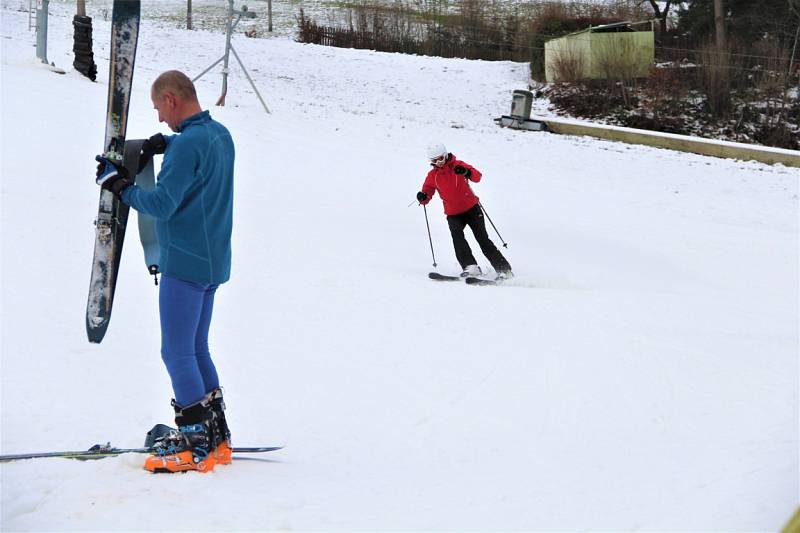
[158,275,219,407]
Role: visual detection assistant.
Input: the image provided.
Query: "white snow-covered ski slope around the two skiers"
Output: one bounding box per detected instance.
[0,1,800,531]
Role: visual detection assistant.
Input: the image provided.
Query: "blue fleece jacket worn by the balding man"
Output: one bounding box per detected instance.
[122,111,234,284]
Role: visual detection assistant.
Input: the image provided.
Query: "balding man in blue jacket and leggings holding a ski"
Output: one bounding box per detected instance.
[97,70,234,472]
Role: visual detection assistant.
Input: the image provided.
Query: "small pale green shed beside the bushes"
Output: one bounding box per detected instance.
[544,22,655,83]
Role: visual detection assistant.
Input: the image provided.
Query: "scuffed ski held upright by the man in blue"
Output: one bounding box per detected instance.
[86,0,140,343]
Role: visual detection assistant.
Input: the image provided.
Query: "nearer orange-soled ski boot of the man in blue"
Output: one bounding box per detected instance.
[144,398,216,473]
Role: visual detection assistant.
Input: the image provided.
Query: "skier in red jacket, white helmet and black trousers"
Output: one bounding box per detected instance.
[417,143,513,278]
